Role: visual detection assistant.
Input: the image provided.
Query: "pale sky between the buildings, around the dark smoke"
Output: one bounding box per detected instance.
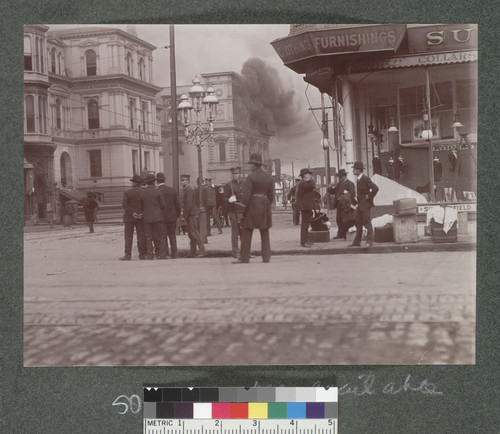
[49,24,324,175]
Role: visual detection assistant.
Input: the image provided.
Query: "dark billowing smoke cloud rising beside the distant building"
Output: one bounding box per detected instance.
[233,58,300,134]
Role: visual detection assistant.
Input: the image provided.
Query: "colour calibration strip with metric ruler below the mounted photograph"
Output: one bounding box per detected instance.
[143,387,338,434]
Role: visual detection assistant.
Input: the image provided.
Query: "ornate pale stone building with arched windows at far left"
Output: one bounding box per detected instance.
[24,25,161,223]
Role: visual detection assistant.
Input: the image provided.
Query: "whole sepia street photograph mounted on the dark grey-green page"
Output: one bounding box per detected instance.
[19,23,478,367]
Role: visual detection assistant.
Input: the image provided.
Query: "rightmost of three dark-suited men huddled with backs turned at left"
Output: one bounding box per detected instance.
[156,172,181,259]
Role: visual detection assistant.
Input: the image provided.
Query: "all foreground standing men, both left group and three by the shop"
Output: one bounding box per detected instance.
[115,154,378,264]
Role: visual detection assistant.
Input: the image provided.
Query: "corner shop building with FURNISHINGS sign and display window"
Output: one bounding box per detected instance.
[271,24,478,200]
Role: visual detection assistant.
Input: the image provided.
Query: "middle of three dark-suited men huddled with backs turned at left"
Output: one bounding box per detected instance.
[141,173,167,259]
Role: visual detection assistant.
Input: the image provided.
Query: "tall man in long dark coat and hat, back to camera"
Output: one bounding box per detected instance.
[233,154,274,264]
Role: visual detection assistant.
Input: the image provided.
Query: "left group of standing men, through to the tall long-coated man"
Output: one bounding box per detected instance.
[120,154,274,264]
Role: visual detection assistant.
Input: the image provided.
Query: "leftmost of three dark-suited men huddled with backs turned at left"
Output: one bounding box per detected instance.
[120,175,147,261]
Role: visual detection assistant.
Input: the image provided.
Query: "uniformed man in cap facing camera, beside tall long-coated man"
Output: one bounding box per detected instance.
[224,167,244,259]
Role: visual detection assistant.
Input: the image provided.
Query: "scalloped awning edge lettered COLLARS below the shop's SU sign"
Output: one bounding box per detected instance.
[349,50,477,72]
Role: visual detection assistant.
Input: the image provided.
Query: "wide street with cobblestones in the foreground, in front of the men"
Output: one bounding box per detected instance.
[24,220,475,366]
